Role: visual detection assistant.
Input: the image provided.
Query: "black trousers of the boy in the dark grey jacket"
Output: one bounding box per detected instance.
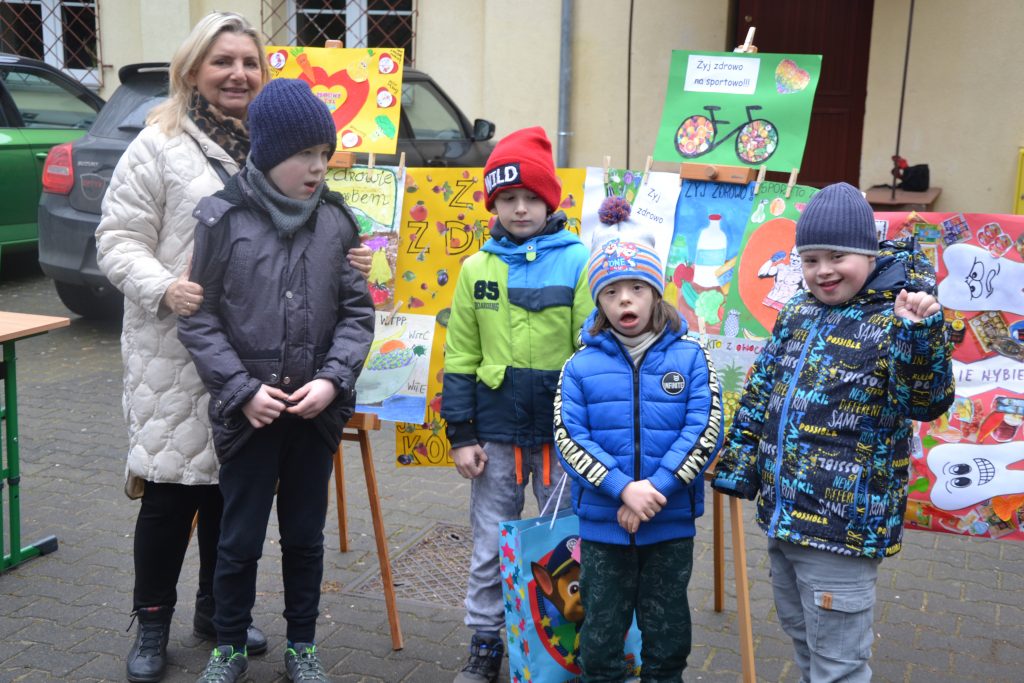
[213,416,334,647]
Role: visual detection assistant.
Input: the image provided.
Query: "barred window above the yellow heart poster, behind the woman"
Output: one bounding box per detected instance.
[261,0,416,65]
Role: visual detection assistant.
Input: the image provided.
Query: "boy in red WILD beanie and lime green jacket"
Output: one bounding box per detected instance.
[441,127,594,683]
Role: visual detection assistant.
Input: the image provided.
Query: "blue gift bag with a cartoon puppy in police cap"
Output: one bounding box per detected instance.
[499,481,640,683]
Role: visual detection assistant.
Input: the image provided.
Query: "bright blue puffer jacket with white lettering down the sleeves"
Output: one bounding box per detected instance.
[555,313,722,546]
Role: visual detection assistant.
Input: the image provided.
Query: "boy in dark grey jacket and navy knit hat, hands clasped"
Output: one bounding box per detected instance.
[178,79,374,683]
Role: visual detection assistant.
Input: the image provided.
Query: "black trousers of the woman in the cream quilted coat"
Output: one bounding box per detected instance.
[132,481,223,609]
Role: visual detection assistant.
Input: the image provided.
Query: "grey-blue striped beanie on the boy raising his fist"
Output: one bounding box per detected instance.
[797,182,879,256]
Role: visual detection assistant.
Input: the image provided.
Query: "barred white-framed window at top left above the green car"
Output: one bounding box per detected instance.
[0,0,101,87]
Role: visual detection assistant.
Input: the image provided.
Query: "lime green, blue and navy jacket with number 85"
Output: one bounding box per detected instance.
[441,211,594,446]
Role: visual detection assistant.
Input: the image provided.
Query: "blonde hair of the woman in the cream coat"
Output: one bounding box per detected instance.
[145,12,270,135]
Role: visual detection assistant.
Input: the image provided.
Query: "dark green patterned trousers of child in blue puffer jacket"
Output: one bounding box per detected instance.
[580,539,693,683]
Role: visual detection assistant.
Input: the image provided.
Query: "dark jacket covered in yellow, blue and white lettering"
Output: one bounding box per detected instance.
[713,242,953,557]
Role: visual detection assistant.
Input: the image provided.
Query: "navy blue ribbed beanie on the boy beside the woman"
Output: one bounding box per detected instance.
[249,78,338,173]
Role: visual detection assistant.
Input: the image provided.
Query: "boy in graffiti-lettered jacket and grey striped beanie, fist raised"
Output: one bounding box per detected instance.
[712,183,953,683]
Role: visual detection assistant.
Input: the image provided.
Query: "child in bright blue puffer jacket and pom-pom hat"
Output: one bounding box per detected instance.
[555,240,722,681]
